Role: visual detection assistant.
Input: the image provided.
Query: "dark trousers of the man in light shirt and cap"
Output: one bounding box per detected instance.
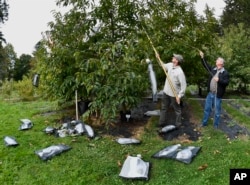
[159,93,181,127]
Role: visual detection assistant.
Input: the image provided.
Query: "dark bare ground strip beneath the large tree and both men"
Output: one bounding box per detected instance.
[55,98,250,143]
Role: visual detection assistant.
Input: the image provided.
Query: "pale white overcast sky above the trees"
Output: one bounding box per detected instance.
[0,0,225,57]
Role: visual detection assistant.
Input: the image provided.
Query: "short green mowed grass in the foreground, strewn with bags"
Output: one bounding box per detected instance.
[0,97,250,185]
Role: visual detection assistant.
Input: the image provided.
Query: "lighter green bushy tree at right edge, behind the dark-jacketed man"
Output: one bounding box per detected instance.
[220,24,250,93]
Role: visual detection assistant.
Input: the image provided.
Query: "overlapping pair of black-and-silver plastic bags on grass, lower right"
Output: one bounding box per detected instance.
[152,144,201,164]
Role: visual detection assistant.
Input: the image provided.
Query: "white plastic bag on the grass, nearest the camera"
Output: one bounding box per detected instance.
[119,156,150,180]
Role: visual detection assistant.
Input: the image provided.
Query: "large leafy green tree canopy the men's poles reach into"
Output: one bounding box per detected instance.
[32,0,222,124]
